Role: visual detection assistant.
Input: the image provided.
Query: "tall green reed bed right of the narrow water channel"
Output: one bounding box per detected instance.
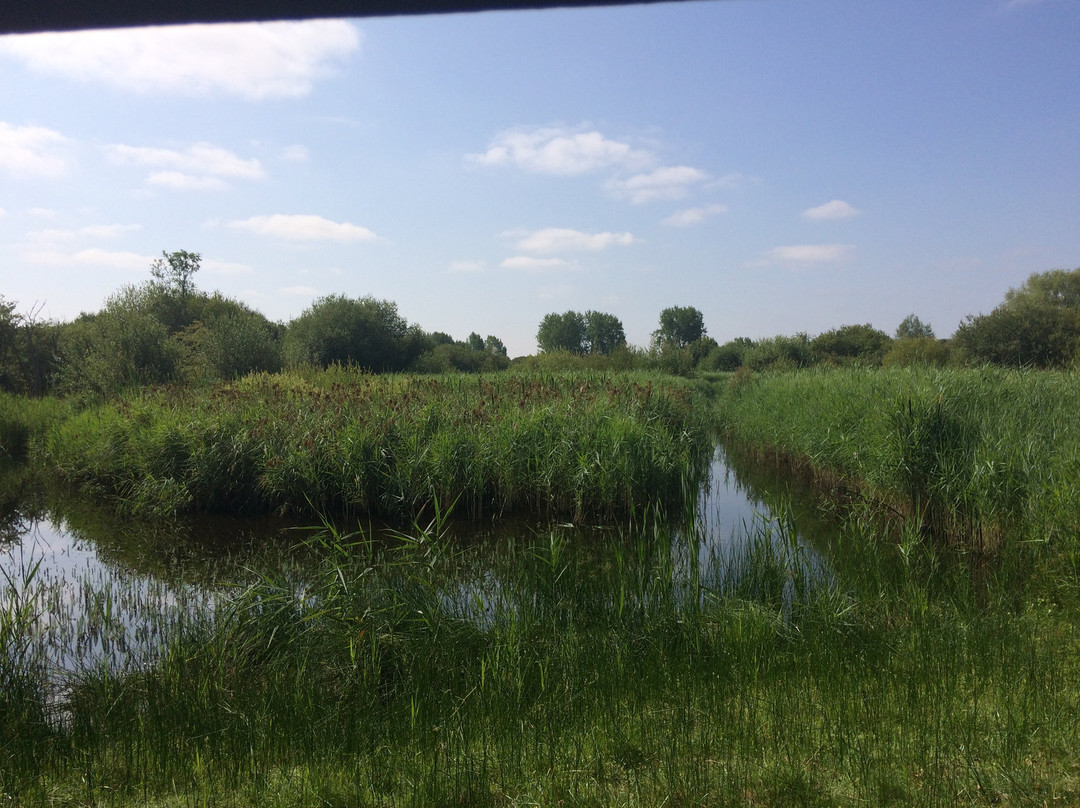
[718,368,1080,549]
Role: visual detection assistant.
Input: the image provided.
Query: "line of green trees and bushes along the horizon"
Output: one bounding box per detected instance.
[0,251,1080,396]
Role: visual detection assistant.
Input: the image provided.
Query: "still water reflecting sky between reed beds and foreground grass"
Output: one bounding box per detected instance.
[0,448,829,673]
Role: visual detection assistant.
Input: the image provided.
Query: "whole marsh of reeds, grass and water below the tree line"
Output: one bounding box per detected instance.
[6,264,1080,806]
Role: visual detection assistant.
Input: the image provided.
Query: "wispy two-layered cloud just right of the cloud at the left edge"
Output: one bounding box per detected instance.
[105,143,266,191]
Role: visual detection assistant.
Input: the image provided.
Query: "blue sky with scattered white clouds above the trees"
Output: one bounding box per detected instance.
[0,0,1080,356]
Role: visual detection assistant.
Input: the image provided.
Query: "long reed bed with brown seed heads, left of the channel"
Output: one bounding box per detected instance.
[43,368,711,519]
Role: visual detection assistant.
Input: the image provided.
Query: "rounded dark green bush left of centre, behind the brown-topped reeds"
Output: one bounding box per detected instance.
[283,295,427,373]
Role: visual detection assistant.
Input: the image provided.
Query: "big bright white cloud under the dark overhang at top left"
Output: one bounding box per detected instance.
[0,19,360,99]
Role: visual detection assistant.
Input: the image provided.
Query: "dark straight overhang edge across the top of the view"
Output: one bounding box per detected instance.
[0,0,695,33]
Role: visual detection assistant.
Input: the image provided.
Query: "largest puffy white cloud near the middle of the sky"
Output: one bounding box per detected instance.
[468,129,652,175]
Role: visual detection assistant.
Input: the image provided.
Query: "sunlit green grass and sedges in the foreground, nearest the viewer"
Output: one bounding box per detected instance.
[8,512,1080,807]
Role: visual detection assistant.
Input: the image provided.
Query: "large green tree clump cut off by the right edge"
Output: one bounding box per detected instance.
[953,269,1080,367]
